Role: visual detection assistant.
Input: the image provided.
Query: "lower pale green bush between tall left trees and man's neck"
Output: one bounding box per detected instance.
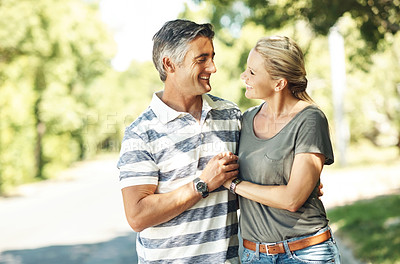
[84,62,164,155]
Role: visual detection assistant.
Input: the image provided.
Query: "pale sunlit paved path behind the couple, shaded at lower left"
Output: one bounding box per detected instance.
[0,156,400,264]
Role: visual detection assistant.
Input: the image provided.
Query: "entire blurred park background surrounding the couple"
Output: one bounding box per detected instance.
[0,0,400,263]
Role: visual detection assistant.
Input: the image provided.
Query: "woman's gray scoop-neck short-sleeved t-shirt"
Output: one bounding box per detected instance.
[239,105,333,243]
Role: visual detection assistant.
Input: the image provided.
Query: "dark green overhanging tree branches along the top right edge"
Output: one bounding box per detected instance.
[193,0,400,51]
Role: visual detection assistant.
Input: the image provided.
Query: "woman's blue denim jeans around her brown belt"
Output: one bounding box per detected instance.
[241,227,341,264]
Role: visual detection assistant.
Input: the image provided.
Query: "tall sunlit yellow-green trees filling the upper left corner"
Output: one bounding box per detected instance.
[0,0,115,192]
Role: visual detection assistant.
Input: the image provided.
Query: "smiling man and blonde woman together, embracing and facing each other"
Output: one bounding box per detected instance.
[118,20,340,263]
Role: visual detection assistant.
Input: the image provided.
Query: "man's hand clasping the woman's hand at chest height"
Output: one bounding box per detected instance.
[200,152,239,192]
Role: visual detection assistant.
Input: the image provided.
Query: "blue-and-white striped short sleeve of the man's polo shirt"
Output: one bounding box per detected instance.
[117,128,159,189]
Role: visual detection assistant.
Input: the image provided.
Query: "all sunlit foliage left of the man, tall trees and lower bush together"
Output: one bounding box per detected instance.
[0,0,167,194]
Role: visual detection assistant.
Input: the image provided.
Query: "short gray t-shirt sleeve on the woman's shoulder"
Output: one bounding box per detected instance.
[295,110,334,165]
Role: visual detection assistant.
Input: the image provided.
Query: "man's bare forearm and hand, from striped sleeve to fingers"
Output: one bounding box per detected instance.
[122,152,239,232]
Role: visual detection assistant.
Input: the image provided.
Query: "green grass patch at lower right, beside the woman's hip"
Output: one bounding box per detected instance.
[328,194,400,264]
